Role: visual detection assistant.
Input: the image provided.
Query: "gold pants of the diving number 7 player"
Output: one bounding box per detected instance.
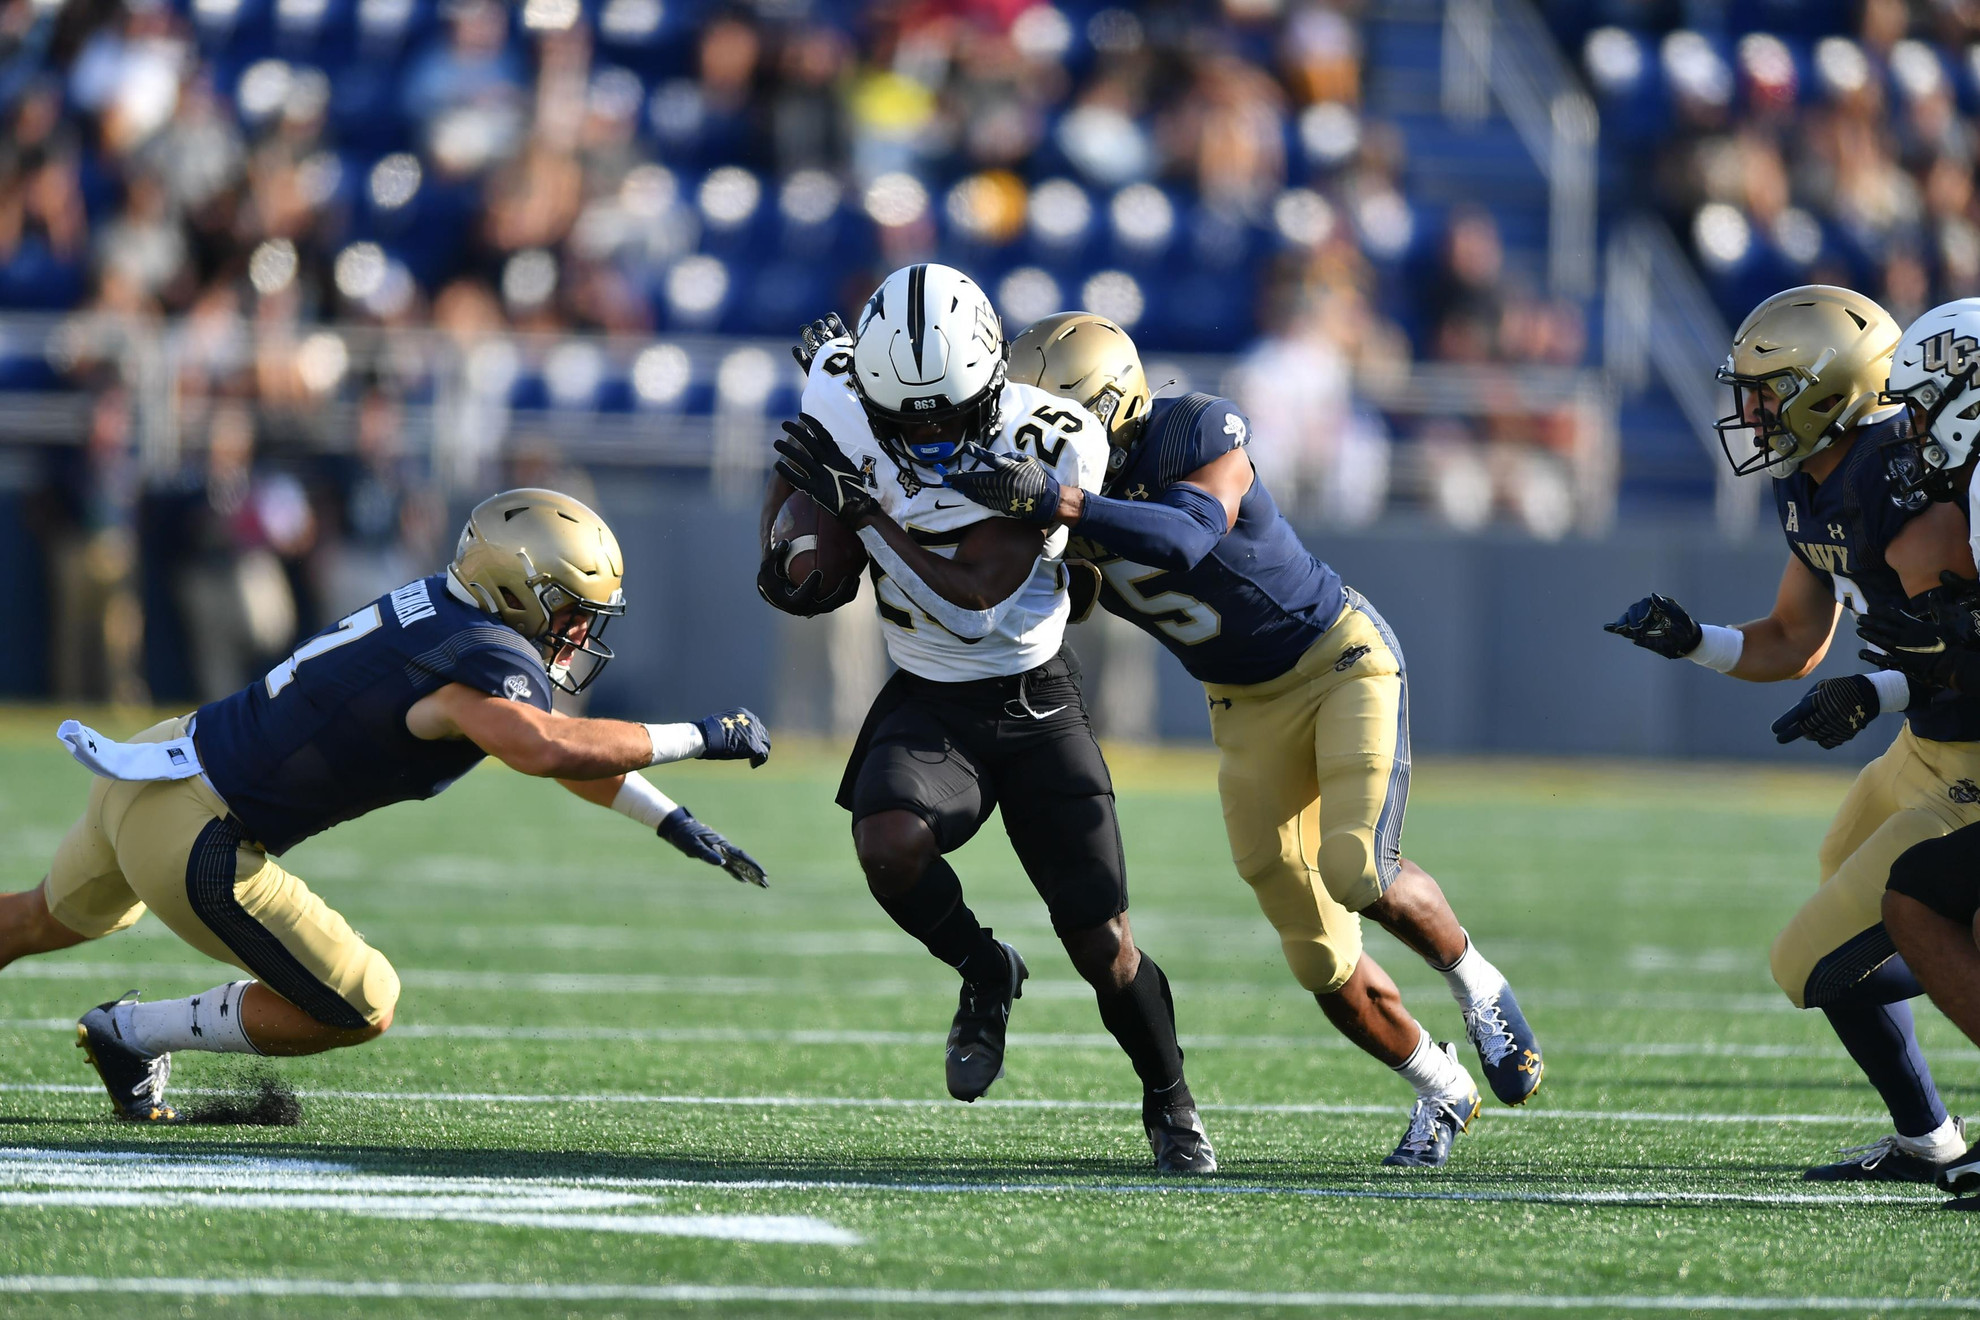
[48,718,398,1029]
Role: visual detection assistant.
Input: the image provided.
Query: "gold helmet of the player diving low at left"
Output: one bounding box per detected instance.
[447,487,626,693]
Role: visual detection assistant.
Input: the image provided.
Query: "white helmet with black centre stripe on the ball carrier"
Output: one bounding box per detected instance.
[853,261,1006,481]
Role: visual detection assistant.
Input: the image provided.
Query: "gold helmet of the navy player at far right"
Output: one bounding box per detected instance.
[1715,285,1901,477]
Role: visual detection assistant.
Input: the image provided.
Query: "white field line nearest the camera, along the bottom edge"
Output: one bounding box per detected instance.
[0,1274,1980,1314]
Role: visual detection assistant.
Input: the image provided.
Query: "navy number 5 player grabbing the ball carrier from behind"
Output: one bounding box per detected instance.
[948,313,1542,1166]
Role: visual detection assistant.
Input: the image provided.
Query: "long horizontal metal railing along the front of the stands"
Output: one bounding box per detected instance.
[0,313,1618,532]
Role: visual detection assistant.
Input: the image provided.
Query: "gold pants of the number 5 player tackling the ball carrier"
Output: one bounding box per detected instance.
[1204,592,1410,993]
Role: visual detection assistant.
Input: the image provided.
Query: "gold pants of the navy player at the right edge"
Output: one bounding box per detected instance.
[1768,724,1980,1007]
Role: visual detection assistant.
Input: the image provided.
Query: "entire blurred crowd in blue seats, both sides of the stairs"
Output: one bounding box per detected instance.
[15,0,1980,699]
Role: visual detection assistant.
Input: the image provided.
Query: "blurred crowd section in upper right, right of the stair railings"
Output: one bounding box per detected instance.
[1546,0,1980,323]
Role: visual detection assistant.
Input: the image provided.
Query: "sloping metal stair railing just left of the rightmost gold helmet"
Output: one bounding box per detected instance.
[1602,216,1766,540]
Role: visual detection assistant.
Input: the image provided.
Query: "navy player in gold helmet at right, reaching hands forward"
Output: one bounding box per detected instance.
[1608,285,1980,1181]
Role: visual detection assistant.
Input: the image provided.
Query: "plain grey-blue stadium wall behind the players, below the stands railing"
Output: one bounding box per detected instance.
[578,475,1895,762]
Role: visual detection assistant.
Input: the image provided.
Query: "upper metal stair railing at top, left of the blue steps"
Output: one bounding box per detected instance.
[1441,0,1602,299]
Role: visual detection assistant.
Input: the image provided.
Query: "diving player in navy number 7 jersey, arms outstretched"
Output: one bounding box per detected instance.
[0,491,770,1122]
